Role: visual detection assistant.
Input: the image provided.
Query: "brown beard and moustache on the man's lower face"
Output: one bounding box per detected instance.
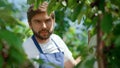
[32,29,53,40]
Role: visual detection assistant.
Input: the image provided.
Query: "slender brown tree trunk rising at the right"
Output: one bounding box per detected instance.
[96,15,107,68]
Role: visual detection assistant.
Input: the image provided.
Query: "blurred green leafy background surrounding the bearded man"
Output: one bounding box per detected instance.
[0,0,120,68]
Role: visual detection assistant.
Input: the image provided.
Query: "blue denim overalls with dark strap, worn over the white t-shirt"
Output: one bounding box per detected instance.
[32,35,64,68]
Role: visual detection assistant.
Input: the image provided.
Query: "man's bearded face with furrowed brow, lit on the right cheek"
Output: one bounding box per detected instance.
[30,12,54,40]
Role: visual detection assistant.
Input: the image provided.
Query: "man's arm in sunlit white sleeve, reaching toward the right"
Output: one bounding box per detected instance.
[54,35,80,68]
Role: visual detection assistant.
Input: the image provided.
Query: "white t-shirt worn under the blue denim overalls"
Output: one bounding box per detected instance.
[23,34,73,68]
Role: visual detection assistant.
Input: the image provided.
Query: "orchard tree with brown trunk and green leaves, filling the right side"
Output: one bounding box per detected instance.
[28,0,120,68]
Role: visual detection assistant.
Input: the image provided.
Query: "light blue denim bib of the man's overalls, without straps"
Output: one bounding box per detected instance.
[39,52,64,68]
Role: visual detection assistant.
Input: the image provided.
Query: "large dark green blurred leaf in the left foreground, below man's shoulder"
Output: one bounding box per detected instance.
[0,30,26,66]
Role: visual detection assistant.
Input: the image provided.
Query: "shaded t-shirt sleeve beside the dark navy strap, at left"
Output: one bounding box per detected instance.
[22,38,39,68]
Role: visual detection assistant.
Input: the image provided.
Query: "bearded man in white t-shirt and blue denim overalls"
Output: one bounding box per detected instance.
[23,2,79,68]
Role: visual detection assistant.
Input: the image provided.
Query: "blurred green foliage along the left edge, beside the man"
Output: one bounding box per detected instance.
[0,0,30,68]
